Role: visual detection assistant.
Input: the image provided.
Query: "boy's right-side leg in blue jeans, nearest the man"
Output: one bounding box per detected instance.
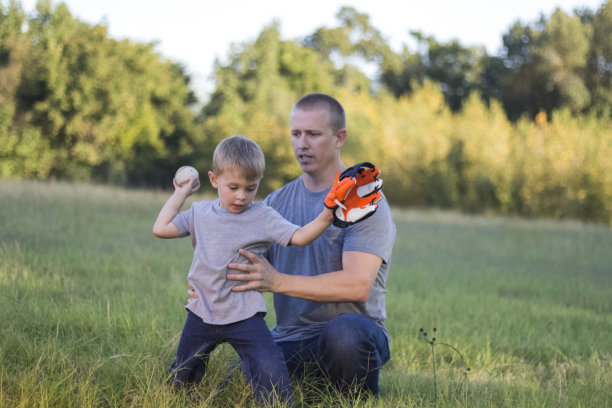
[223,316,293,406]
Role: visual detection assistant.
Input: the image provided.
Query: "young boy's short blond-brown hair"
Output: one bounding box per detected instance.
[213,135,266,180]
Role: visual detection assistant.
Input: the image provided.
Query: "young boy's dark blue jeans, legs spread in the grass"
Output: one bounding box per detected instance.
[170,310,293,406]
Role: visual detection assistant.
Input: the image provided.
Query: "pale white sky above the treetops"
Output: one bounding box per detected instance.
[21,0,605,101]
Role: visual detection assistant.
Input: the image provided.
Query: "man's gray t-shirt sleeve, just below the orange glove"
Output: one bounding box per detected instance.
[342,198,395,263]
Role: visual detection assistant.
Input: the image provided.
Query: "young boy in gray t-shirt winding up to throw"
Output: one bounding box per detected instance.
[153,136,335,405]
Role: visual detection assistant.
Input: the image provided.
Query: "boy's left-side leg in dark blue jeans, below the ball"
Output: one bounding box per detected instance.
[170,310,216,384]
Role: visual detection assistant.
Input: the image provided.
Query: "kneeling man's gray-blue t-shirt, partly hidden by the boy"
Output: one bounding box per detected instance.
[264,177,395,341]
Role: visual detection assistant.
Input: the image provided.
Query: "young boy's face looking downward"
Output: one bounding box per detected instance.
[208,169,261,214]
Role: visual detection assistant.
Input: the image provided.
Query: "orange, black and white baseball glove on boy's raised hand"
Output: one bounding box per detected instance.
[325,162,382,228]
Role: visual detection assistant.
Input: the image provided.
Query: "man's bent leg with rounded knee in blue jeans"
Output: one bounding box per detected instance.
[318,313,390,396]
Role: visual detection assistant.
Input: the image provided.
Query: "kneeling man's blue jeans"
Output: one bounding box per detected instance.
[277,313,390,397]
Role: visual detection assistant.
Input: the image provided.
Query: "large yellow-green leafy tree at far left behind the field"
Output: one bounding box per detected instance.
[0,0,194,184]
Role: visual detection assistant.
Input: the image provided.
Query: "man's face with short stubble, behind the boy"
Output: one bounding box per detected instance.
[289,109,342,174]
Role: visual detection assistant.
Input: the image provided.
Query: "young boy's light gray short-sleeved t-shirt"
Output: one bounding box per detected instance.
[172,200,298,325]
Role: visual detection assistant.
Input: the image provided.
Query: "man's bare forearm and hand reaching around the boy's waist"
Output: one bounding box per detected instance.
[227,249,382,302]
